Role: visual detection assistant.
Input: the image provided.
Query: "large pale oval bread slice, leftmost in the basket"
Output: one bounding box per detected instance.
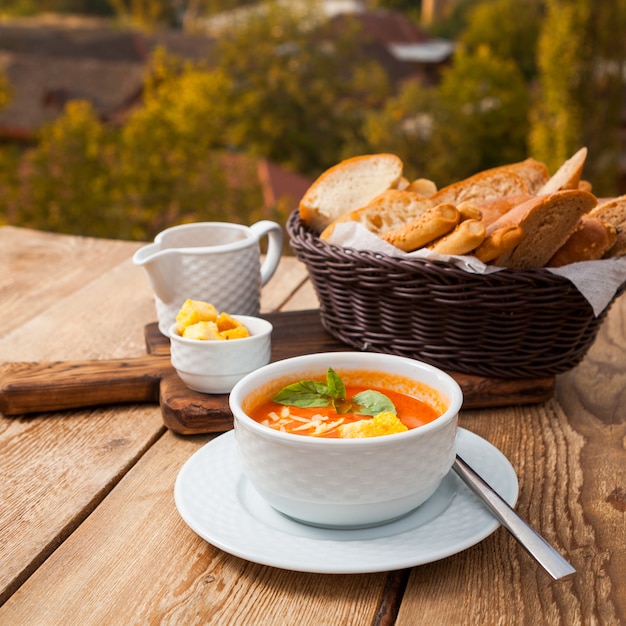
[299,154,403,232]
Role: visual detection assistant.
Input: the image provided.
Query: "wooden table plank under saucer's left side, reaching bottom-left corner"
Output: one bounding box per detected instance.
[0,432,393,626]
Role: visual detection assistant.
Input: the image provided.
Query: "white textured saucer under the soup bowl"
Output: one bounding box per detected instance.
[174,428,518,574]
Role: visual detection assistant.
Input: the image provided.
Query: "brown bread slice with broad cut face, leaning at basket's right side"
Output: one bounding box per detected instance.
[487,189,597,269]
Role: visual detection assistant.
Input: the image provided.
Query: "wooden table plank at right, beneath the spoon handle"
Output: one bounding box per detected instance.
[397,296,626,626]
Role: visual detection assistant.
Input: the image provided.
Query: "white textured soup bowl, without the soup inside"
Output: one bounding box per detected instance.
[230,352,462,527]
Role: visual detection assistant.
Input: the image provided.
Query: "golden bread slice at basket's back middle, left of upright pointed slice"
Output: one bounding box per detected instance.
[431,168,528,204]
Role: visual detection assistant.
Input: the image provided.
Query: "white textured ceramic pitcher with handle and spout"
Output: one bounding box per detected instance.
[133,220,283,335]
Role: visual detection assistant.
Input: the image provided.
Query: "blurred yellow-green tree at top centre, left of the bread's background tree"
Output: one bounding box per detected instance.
[206,3,390,175]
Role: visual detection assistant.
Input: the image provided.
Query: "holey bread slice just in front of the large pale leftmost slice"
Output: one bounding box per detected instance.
[320,189,432,240]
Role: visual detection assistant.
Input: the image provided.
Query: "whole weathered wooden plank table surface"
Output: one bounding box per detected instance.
[0,227,626,626]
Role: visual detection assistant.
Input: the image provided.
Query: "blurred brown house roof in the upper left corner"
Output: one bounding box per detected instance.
[0,19,214,139]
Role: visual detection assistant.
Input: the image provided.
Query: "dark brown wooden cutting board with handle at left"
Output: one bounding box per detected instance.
[0,310,555,435]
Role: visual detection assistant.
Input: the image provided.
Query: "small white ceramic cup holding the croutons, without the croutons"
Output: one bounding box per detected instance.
[169,315,272,393]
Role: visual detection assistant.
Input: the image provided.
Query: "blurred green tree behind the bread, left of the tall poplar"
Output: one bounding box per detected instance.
[358,46,530,187]
